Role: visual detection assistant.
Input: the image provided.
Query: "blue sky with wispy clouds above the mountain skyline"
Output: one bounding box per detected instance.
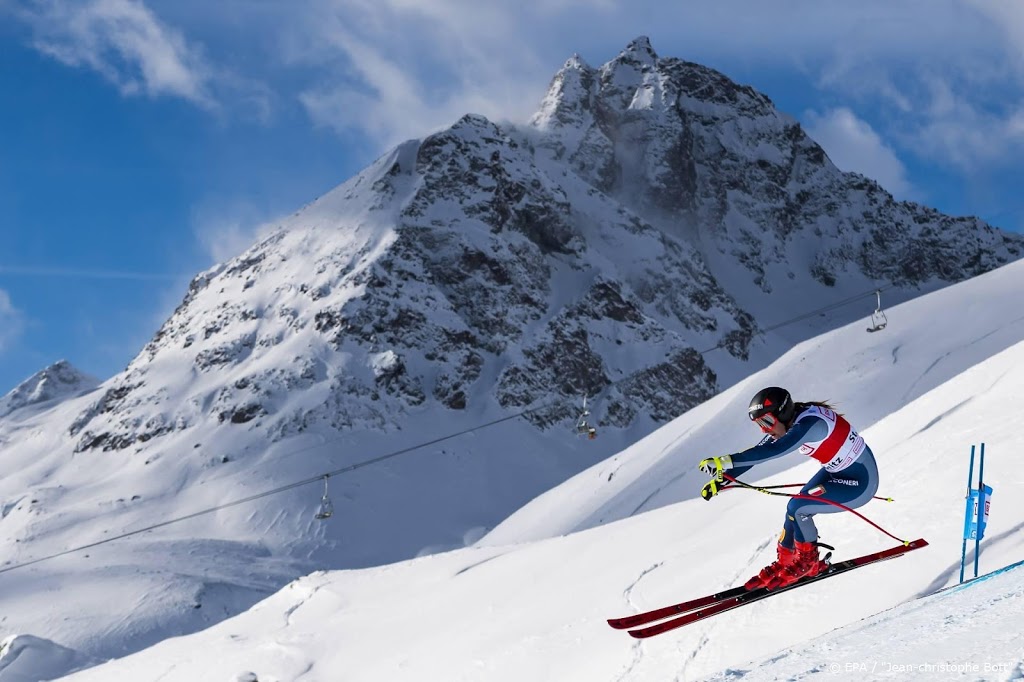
[0,0,1024,394]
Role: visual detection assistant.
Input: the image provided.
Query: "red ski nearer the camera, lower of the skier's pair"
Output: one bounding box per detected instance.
[622,539,928,639]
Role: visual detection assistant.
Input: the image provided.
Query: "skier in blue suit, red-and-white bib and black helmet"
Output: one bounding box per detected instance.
[697,386,879,590]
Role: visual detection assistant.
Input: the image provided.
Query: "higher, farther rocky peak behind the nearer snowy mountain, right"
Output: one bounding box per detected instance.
[532,38,1021,294]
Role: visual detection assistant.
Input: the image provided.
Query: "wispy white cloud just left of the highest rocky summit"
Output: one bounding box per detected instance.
[284,0,552,145]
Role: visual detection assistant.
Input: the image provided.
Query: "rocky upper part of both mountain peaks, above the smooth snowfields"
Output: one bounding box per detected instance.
[71,39,1024,452]
